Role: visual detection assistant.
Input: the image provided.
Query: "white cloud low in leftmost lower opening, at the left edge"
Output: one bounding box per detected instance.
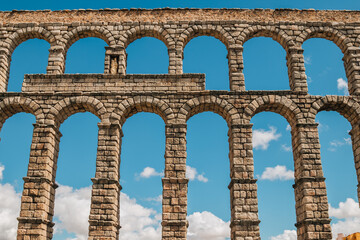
[0,184,20,240]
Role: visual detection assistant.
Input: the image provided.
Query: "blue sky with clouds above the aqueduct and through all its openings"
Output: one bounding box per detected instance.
[0,0,360,240]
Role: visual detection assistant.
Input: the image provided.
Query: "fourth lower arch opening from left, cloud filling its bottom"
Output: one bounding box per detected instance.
[186,112,231,240]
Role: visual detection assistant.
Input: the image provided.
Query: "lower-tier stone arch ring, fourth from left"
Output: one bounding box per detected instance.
[178,96,241,127]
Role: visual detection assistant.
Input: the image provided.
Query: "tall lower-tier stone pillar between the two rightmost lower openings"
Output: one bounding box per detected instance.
[291,124,332,240]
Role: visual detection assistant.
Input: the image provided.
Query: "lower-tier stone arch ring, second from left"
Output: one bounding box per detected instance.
[47,96,106,127]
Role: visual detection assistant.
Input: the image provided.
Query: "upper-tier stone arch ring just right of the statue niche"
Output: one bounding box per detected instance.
[118,25,175,49]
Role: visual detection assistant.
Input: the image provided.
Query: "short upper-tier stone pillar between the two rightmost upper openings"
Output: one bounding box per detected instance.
[286,47,308,93]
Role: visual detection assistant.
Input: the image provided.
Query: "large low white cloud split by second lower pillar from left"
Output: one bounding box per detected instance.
[55,186,161,240]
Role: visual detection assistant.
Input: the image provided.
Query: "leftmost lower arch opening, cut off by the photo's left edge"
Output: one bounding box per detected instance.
[0,113,35,239]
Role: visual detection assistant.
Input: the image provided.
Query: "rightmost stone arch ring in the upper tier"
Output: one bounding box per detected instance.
[296,26,353,53]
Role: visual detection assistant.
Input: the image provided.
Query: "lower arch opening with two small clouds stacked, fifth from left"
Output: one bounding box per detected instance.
[251,112,297,239]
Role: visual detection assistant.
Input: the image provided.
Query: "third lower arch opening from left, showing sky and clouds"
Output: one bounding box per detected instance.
[120,112,165,239]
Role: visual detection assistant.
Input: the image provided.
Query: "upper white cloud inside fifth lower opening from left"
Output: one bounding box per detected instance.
[252,126,281,150]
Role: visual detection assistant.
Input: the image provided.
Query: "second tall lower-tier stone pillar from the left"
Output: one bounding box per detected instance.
[89,123,122,240]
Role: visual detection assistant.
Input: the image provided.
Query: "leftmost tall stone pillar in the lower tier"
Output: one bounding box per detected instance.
[17,124,61,240]
